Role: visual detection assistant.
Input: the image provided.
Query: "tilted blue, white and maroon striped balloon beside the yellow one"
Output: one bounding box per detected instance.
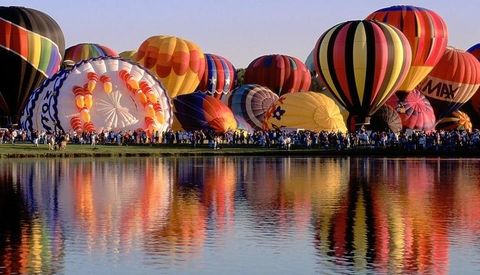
[222,84,278,130]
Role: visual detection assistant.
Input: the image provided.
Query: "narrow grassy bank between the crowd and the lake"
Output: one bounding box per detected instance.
[0,144,480,158]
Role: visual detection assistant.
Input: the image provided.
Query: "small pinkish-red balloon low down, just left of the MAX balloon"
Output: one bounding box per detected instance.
[386,90,435,131]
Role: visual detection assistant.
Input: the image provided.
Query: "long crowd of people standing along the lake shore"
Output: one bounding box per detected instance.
[0,128,480,151]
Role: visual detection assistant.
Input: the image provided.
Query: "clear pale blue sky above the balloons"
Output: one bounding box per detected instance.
[6,0,480,68]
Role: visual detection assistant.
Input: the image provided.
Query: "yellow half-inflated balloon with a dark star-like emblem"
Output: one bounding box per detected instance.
[263,92,347,132]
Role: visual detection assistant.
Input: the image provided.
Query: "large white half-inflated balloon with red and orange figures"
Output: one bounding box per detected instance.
[21,57,172,136]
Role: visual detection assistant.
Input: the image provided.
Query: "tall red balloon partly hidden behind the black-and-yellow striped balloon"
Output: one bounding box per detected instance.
[367,6,448,93]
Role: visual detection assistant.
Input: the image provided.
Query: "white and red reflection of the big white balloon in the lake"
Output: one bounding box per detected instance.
[70,159,171,251]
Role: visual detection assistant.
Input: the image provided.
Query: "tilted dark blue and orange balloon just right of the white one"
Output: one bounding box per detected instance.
[173,92,237,133]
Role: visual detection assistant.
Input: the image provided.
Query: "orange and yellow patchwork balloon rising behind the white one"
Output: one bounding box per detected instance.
[134,35,205,98]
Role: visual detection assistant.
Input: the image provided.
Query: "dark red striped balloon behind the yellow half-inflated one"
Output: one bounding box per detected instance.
[244,54,312,95]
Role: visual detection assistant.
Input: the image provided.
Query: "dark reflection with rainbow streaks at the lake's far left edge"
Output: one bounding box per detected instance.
[0,162,65,274]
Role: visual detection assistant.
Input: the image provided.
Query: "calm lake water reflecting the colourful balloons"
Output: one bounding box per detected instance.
[0,157,480,274]
